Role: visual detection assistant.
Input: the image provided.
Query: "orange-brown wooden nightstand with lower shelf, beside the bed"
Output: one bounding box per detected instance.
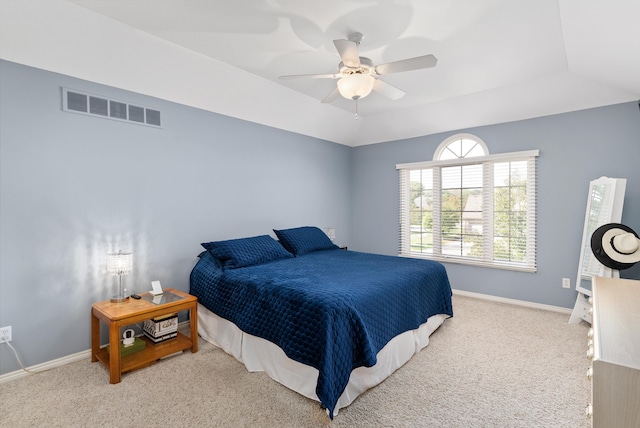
[91,288,198,383]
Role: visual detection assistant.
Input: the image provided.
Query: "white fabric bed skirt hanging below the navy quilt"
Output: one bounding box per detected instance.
[198,303,448,415]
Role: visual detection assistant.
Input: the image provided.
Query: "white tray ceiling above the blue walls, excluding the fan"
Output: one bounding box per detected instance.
[0,0,640,146]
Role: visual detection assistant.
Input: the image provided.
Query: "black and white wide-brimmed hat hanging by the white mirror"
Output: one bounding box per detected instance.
[591,223,640,270]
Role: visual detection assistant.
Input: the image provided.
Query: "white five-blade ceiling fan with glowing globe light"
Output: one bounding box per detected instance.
[280,33,438,110]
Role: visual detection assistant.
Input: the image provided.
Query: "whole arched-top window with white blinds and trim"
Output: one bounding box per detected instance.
[396,134,538,272]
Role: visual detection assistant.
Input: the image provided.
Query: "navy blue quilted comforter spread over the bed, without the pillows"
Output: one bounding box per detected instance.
[190,250,453,418]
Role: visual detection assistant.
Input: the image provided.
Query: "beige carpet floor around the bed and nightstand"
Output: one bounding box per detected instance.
[0,296,589,428]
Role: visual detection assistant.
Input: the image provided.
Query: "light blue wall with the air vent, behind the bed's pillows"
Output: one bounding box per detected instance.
[0,61,351,373]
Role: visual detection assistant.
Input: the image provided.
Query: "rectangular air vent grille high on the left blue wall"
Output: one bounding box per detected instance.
[62,88,161,127]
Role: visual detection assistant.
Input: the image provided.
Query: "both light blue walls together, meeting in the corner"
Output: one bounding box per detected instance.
[0,61,640,374]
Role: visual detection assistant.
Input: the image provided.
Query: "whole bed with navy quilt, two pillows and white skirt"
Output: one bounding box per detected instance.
[190,227,453,418]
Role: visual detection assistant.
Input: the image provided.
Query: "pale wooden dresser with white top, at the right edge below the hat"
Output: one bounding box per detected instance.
[587,277,640,428]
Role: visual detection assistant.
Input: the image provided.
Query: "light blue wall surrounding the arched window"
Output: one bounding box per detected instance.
[352,102,640,308]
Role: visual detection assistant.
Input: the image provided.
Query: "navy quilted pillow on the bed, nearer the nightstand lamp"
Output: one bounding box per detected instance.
[201,235,293,269]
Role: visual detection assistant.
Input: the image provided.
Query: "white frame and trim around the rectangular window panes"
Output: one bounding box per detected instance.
[396,149,540,272]
